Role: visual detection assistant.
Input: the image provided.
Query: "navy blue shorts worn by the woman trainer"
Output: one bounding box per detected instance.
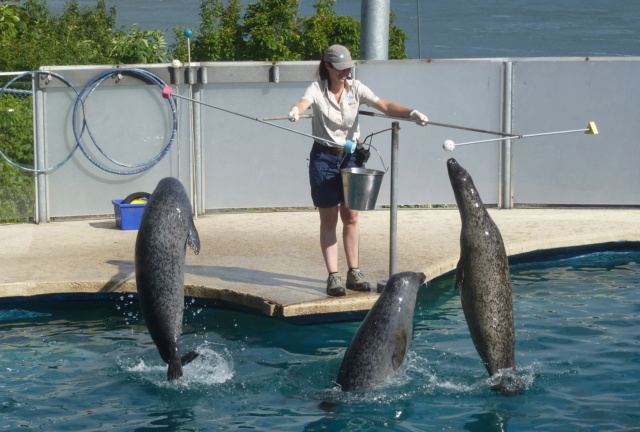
[309,145,356,208]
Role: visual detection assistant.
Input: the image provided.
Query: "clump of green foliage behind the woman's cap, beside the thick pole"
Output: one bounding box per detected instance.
[170,0,407,61]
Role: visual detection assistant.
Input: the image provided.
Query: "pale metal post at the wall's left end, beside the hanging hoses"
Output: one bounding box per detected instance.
[31,74,49,224]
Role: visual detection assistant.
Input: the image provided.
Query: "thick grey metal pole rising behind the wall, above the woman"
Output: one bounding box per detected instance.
[360,0,390,60]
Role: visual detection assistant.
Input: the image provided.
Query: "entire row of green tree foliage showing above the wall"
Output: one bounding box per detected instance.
[0,0,407,71]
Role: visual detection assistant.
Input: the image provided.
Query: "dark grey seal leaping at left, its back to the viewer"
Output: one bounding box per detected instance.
[135,177,200,380]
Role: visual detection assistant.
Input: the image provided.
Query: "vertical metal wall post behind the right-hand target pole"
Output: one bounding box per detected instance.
[500,62,513,209]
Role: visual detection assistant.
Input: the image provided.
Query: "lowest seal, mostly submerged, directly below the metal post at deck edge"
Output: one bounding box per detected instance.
[336,272,427,391]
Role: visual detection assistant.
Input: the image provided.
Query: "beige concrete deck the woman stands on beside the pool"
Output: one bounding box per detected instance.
[0,208,640,320]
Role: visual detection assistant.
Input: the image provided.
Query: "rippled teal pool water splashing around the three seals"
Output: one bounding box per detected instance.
[0,251,640,431]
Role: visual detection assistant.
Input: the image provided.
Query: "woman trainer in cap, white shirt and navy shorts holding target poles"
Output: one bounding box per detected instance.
[289,45,428,296]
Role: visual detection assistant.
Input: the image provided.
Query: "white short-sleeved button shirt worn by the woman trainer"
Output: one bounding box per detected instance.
[302,80,379,147]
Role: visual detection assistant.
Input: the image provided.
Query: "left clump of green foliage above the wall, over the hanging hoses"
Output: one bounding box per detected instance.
[0,0,167,71]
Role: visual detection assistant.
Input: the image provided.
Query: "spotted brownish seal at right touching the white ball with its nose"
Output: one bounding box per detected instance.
[447,158,521,393]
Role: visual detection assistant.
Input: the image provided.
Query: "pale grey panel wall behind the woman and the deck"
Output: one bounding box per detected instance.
[44,57,640,217]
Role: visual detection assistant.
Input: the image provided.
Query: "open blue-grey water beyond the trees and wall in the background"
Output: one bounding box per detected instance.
[47,0,640,58]
